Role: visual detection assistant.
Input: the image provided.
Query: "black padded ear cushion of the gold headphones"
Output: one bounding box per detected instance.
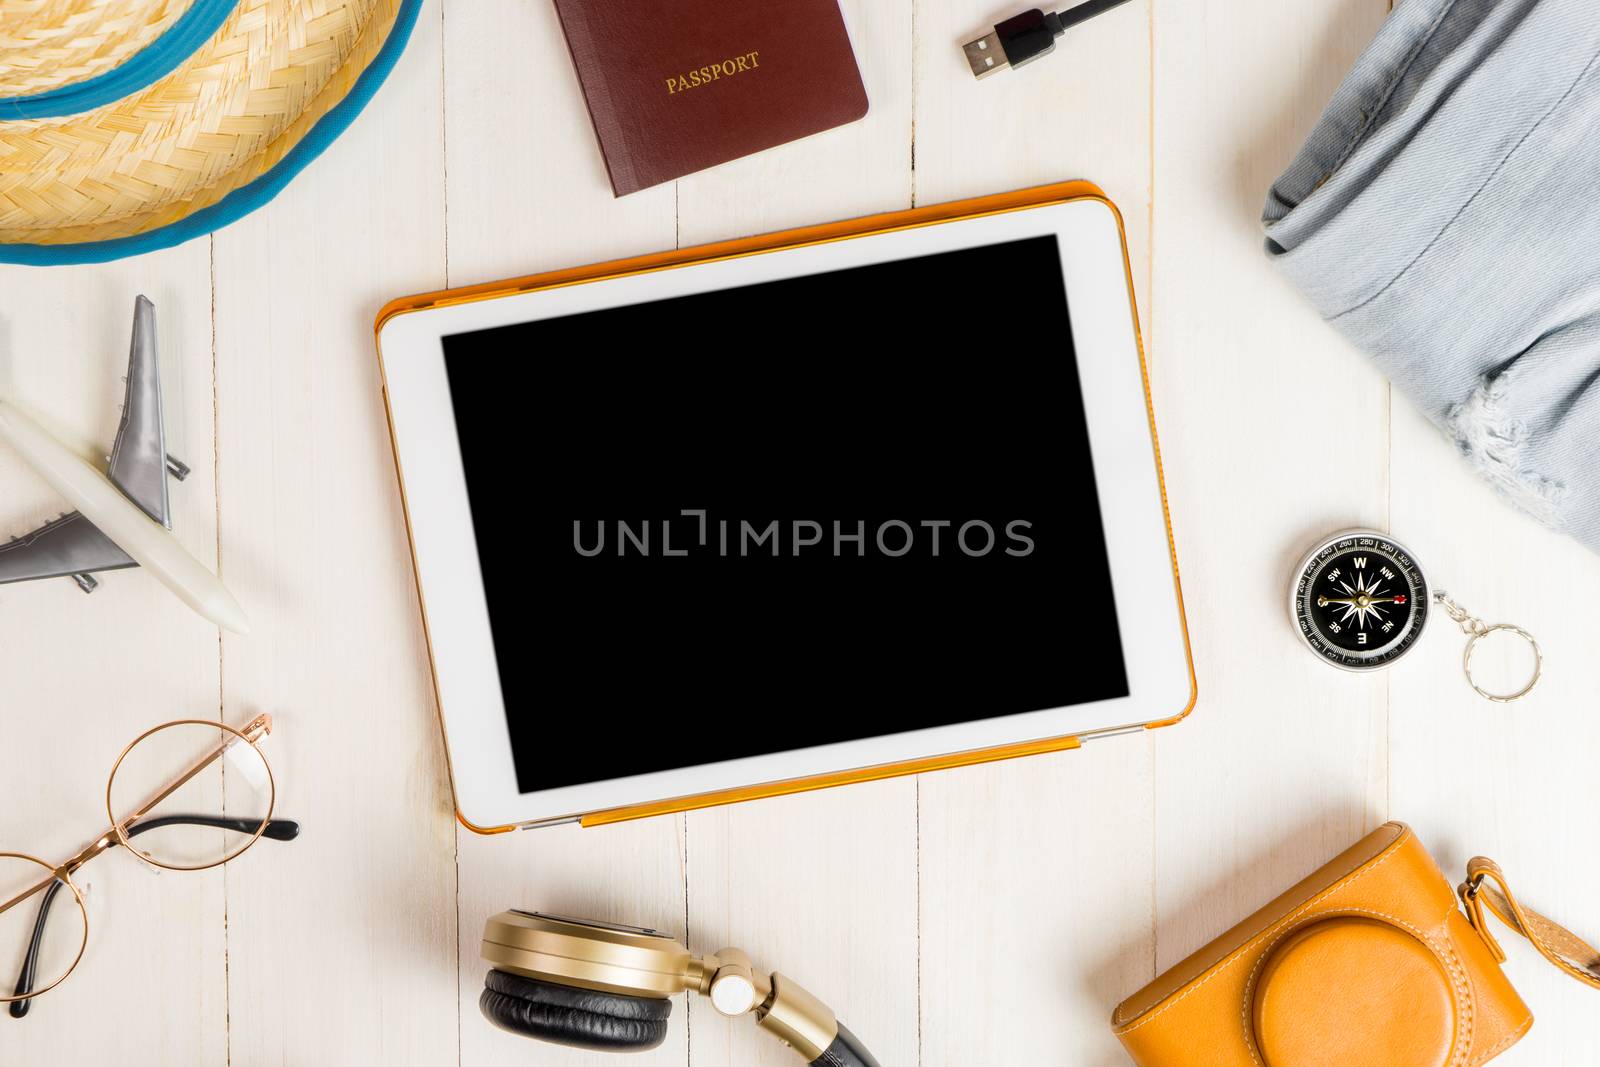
[478,971,672,1051]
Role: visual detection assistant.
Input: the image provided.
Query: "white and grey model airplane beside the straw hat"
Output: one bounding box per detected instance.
[0,296,250,633]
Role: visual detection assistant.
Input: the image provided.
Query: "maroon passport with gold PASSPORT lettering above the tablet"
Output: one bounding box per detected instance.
[555,0,867,197]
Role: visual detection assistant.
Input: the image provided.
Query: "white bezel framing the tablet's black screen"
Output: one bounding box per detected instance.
[379,198,1194,829]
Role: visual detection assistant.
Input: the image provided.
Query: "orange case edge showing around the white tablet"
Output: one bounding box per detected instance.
[374,181,1198,833]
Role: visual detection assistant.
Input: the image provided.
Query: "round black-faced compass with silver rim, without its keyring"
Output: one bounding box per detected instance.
[1293,533,1427,670]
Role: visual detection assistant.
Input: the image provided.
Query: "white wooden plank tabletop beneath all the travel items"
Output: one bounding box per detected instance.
[0,0,1600,1067]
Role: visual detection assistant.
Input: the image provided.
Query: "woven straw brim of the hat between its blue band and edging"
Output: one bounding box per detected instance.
[0,0,402,245]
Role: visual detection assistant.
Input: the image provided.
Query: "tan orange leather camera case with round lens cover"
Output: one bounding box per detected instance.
[1112,822,1542,1067]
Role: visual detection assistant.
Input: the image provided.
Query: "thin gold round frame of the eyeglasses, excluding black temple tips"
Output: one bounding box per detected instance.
[0,713,278,1005]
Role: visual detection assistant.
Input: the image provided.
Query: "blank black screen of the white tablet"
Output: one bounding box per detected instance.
[443,237,1128,792]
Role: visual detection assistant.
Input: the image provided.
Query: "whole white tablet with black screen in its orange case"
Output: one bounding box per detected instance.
[378,182,1195,830]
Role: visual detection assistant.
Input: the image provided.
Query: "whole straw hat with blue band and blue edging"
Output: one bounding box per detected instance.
[0,0,421,264]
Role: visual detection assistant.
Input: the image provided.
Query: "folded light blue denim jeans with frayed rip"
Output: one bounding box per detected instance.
[1262,0,1600,550]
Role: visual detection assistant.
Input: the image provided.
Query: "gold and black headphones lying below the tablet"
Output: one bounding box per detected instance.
[478,912,878,1067]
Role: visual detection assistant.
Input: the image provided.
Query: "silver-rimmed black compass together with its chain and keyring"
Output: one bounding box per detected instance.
[1290,530,1544,704]
